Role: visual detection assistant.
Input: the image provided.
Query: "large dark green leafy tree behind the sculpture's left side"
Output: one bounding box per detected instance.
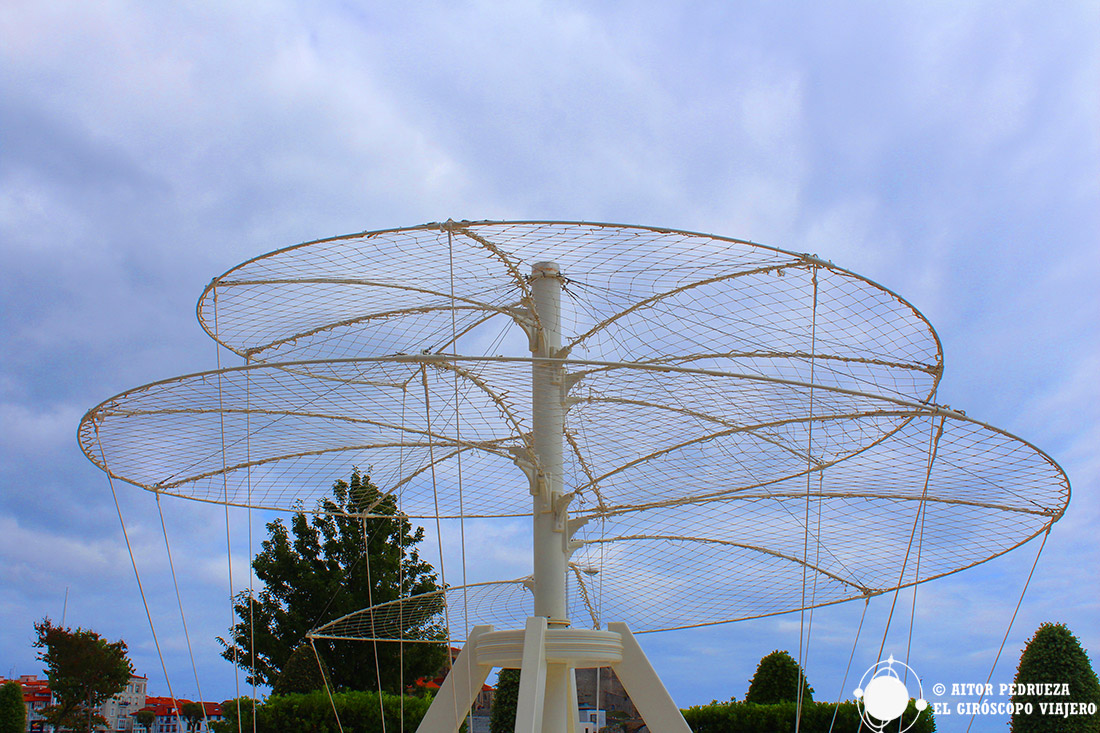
[218,469,447,692]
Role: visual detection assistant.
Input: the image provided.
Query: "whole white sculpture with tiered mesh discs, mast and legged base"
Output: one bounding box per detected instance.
[79,221,1069,733]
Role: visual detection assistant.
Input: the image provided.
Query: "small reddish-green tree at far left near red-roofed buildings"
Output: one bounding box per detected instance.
[34,619,134,732]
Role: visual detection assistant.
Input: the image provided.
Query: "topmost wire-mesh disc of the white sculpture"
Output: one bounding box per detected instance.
[198,221,942,398]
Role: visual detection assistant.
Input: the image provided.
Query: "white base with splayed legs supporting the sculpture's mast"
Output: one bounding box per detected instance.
[417,616,691,733]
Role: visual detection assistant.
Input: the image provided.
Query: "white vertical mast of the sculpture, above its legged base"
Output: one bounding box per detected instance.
[531,262,568,624]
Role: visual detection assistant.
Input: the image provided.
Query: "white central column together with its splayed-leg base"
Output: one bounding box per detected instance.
[418,256,691,733]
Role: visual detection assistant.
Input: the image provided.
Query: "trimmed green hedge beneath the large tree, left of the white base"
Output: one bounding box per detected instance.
[211,690,432,733]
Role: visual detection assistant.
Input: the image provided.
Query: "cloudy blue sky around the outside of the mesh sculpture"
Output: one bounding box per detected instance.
[0,0,1100,731]
